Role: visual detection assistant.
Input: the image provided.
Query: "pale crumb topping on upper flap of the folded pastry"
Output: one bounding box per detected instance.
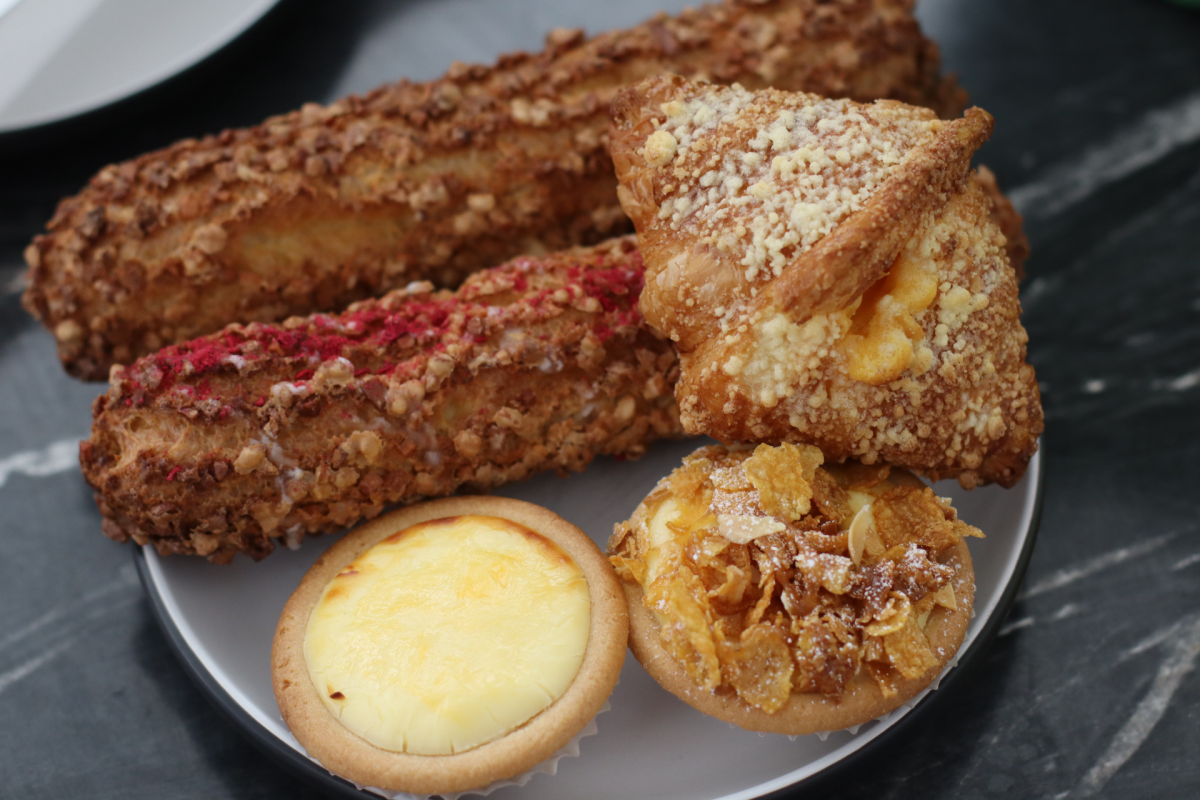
[657,85,942,281]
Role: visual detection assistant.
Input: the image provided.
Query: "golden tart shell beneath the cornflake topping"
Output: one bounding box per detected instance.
[622,542,974,735]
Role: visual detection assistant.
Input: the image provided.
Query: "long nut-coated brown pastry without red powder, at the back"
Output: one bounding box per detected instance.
[25,0,964,379]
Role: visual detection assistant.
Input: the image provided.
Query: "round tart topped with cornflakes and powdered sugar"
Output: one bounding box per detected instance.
[608,444,982,735]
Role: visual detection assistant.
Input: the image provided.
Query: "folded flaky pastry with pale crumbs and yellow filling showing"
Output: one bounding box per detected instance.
[612,78,1043,488]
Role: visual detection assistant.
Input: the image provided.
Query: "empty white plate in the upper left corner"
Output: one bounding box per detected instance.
[0,0,277,133]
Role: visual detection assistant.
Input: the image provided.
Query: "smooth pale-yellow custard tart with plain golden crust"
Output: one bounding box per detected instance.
[271,497,629,794]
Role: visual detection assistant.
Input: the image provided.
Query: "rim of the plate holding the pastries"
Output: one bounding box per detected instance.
[133,448,1045,800]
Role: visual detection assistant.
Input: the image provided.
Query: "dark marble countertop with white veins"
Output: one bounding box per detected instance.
[0,0,1200,800]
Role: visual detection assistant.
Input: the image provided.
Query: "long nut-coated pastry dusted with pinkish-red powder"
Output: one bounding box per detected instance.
[79,237,682,563]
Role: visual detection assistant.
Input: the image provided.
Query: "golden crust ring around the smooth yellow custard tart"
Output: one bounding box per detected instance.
[271,497,629,794]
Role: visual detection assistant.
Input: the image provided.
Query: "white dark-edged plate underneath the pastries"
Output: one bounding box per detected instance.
[138,440,1040,800]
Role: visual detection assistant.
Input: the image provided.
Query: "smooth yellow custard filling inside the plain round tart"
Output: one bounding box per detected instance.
[305,516,592,756]
